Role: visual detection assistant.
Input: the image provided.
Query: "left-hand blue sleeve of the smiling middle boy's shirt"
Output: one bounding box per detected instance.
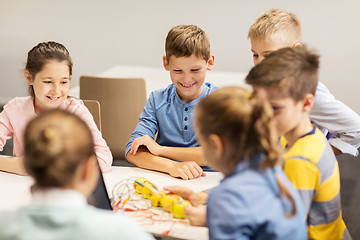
[125,92,158,157]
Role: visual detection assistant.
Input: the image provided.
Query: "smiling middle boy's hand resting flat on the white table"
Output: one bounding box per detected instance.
[169,161,206,180]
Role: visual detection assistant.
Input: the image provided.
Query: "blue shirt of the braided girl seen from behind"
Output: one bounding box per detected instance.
[207,154,307,240]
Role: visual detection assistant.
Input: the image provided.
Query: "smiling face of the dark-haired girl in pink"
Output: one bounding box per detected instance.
[24,60,70,113]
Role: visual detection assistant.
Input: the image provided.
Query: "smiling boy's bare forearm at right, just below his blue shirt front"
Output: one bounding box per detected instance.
[159,146,208,166]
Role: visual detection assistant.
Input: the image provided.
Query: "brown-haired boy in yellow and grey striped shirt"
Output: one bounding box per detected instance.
[245,47,351,239]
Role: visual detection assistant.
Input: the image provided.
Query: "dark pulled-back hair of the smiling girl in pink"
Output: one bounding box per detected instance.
[25,42,73,97]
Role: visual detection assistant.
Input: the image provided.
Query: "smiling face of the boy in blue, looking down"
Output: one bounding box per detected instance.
[163,54,214,103]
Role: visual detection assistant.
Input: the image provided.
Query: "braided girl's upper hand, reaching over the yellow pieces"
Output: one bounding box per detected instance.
[164,186,209,207]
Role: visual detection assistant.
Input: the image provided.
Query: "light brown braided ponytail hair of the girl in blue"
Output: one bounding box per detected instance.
[195,87,296,216]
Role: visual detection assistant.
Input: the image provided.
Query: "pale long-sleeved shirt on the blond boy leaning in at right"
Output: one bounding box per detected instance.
[310,82,360,156]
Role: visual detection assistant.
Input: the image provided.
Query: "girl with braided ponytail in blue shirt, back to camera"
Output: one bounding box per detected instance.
[194,87,307,239]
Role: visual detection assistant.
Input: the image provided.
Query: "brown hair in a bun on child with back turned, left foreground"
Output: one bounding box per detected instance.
[24,109,95,188]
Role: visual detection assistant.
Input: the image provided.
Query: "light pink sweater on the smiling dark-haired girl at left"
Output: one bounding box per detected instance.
[0,96,113,172]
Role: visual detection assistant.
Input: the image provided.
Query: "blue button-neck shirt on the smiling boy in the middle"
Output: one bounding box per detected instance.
[125,83,216,156]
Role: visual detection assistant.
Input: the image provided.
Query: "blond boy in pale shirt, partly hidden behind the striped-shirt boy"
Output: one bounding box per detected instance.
[248,9,360,156]
